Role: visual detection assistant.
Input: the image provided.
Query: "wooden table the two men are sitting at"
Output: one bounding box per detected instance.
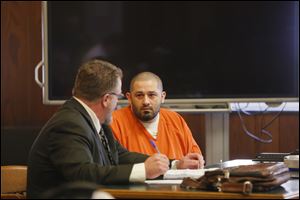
[102,160,299,199]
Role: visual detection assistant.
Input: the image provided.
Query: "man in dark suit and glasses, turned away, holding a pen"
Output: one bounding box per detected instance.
[27,60,199,198]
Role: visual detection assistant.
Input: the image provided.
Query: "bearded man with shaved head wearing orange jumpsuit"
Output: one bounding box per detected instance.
[111,72,204,168]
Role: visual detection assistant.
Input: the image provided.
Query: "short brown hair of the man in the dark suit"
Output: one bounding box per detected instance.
[72,59,123,101]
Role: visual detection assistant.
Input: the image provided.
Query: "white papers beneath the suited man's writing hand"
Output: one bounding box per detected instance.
[164,168,218,180]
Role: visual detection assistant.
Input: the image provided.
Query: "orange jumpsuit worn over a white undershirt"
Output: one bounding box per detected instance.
[111,106,201,160]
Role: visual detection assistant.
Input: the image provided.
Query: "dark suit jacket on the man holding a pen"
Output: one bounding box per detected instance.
[27,98,148,198]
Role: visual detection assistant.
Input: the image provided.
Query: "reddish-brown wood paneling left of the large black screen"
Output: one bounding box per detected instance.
[1,1,57,127]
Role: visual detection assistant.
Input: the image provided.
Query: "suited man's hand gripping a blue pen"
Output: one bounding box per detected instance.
[145,154,170,179]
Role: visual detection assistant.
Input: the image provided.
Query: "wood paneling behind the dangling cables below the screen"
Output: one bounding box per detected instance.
[229,112,299,159]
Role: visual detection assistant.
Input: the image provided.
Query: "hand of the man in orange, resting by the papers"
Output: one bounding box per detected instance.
[176,153,205,169]
